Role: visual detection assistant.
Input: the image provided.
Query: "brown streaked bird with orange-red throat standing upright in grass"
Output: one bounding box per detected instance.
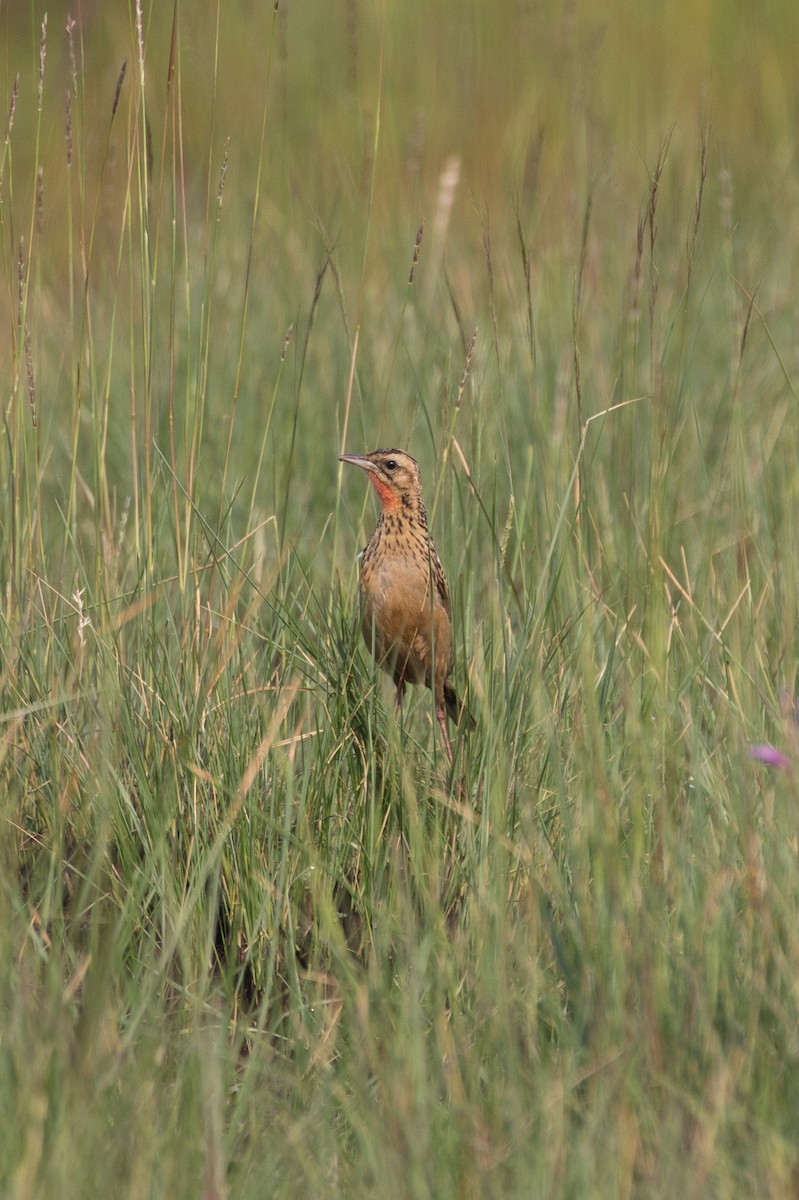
[340,450,474,764]
